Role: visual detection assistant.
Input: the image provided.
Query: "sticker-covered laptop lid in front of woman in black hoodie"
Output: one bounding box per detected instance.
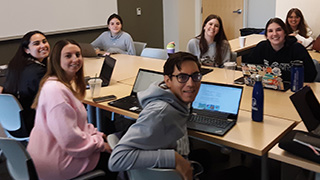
[241,63,290,91]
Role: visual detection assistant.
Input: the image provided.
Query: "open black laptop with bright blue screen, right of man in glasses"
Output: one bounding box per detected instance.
[187,82,243,136]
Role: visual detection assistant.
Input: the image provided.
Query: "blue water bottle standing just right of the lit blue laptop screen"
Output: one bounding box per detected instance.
[251,75,263,122]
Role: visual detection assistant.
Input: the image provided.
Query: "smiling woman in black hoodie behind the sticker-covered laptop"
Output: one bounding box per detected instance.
[245,18,317,82]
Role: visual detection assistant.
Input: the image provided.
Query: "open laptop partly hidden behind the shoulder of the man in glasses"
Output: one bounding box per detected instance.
[108,69,163,114]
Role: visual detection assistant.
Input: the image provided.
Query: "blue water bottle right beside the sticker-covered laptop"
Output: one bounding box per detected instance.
[291,60,304,92]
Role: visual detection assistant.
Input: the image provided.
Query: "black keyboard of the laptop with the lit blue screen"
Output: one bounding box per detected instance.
[189,115,232,128]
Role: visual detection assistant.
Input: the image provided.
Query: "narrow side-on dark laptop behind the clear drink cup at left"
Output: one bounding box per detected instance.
[85,56,116,89]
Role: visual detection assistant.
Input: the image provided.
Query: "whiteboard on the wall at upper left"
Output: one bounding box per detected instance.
[0,0,118,40]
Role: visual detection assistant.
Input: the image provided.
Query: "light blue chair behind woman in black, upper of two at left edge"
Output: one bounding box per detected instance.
[0,94,29,141]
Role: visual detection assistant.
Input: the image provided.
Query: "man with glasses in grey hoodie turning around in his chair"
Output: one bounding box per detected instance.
[109,52,202,180]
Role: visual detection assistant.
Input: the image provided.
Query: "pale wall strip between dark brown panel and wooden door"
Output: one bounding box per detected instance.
[162,0,202,51]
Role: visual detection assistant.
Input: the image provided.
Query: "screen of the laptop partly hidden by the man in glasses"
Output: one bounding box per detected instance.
[131,69,163,95]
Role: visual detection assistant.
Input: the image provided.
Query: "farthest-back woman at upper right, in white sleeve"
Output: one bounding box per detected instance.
[286,8,313,48]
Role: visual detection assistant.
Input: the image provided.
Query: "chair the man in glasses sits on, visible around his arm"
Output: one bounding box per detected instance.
[107,134,183,180]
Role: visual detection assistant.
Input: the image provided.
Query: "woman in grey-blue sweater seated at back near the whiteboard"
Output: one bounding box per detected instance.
[91,14,136,55]
